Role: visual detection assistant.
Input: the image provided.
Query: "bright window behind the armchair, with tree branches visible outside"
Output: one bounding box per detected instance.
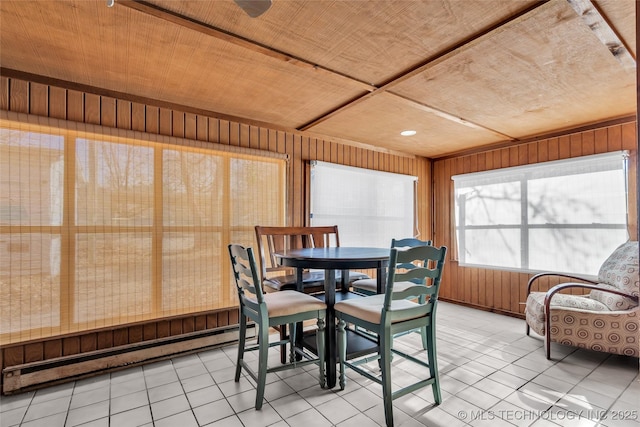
[452,152,628,275]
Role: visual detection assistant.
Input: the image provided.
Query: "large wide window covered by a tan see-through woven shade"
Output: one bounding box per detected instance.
[0,120,286,344]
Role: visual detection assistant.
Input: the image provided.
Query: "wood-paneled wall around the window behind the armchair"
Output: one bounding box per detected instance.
[433,122,638,317]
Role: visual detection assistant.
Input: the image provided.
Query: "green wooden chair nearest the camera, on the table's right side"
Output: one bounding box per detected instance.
[334,246,447,426]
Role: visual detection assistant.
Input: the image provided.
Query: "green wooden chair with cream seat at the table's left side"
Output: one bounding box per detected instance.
[229,245,327,409]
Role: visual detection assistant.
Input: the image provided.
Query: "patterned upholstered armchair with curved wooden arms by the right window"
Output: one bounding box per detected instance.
[525,241,640,359]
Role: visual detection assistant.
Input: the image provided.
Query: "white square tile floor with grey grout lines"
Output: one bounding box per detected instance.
[0,303,640,427]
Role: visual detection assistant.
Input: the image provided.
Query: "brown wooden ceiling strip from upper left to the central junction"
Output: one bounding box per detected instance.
[116,0,376,92]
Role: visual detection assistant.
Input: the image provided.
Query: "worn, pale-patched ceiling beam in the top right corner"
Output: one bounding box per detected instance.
[567,0,636,68]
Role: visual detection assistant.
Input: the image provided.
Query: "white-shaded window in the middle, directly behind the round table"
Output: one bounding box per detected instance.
[311,161,417,248]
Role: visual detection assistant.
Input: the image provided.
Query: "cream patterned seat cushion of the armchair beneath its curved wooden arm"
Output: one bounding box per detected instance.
[525,292,609,335]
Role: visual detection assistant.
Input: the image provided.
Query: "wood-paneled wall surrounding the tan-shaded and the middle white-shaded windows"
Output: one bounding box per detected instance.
[0,76,432,384]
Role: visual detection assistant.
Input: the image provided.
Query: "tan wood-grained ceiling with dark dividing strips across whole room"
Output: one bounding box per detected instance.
[0,0,636,158]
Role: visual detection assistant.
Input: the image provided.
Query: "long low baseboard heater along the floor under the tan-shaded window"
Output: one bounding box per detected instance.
[2,324,255,394]
